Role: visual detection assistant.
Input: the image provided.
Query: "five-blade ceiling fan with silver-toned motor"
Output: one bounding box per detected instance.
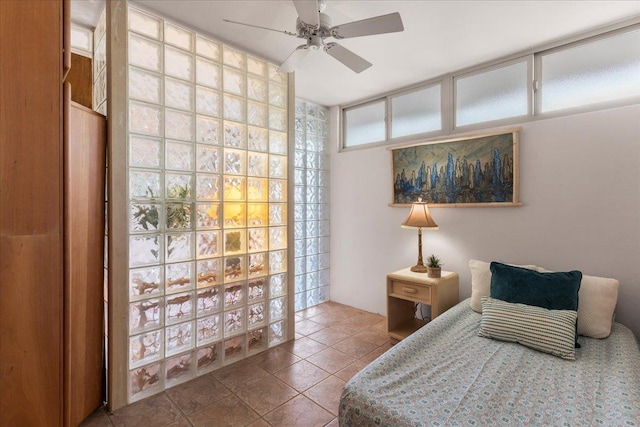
[223,0,404,73]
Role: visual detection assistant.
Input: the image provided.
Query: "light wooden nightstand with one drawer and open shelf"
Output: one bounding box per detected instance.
[387,268,458,344]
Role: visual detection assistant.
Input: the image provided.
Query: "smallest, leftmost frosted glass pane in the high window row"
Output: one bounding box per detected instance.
[344,100,386,148]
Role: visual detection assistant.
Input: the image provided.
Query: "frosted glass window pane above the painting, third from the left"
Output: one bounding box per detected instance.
[455,61,528,126]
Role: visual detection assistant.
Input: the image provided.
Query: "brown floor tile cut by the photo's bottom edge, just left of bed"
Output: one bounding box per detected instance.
[264,395,333,427]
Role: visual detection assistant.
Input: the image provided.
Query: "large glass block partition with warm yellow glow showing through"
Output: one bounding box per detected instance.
[128,8,288,402]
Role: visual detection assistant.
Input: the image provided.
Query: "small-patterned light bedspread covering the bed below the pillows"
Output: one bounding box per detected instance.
[339,300,640,427]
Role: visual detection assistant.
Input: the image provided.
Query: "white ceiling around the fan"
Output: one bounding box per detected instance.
[72,0,640,106]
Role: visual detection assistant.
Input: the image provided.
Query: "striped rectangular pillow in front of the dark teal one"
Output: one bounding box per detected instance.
[478,296,578,360]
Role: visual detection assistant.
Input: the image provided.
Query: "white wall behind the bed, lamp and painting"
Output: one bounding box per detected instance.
[331,105,640,337]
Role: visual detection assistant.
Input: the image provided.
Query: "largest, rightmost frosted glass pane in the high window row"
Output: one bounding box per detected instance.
[541,31,640,113]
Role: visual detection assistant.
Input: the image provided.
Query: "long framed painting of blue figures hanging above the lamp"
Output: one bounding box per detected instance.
[390,128,522,207]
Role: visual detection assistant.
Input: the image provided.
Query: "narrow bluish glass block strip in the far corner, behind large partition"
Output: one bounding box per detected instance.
[294,99,329,311]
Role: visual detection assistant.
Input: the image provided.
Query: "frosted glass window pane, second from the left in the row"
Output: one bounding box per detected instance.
[391,85,442,138]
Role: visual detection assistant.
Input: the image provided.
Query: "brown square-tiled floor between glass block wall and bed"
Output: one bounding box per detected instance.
[82,302,390,427]
